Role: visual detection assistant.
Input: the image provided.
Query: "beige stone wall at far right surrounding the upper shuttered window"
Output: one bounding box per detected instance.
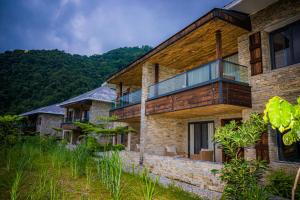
[238,0,300,172]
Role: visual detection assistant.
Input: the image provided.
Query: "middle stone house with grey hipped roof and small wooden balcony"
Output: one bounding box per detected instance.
[59,87,119,144]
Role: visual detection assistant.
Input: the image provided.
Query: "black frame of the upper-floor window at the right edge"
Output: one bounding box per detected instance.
[269,20,300,70]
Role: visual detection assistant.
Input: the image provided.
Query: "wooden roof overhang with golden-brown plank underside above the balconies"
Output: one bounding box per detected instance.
[107,8,251,86]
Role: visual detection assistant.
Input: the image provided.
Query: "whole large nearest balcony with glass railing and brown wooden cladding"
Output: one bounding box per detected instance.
[146,60,251,116]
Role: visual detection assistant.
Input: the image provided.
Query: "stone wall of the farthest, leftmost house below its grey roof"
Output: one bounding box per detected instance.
[36,114,63,135]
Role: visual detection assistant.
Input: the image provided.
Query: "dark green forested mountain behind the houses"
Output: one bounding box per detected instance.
[0,46,151,114]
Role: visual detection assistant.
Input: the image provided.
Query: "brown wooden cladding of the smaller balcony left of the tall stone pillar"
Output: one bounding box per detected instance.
[110,104,141,120]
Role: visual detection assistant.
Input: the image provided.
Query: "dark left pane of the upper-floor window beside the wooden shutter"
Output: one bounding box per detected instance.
[273,31,290,68]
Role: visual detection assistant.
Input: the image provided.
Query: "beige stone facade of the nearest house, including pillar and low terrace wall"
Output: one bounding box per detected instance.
[112,0,300,197]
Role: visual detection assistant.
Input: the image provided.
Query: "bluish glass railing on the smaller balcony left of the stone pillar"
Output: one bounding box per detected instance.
[113,90,142,108]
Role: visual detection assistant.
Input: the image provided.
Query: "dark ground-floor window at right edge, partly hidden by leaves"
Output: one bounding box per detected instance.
[277,132,300,162]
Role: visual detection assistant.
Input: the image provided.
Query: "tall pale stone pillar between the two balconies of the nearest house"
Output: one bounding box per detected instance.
[140,63,155,164]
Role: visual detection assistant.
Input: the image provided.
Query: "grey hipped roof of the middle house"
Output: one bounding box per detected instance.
[59,87,116,106]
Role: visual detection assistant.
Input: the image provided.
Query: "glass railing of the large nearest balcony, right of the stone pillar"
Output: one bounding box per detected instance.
[148,60,248,98]
